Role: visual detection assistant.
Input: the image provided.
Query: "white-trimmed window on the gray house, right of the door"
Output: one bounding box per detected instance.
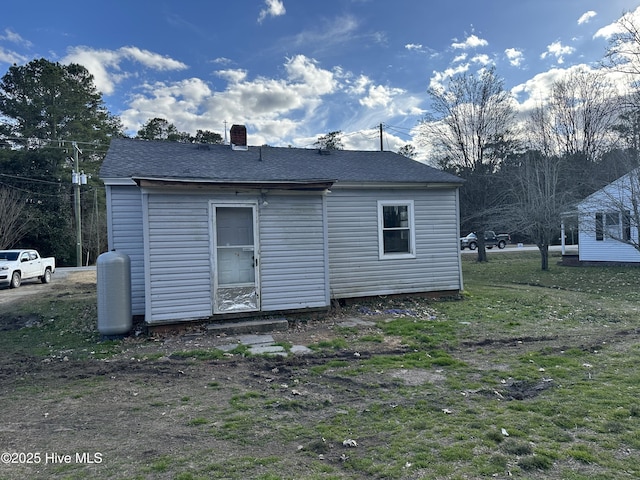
[378,200,416,259]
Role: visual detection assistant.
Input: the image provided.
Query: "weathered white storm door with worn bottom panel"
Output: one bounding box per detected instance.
[213,205,260,313]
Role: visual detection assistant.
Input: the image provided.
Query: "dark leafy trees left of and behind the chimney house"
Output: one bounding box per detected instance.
[0,58,223,265]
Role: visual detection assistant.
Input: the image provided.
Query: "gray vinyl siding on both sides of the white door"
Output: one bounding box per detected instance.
[146,193,329,323]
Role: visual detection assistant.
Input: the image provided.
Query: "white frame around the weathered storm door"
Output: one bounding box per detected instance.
[209,200,262,314]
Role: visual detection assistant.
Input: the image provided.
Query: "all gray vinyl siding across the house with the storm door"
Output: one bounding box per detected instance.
[108,186,462,323]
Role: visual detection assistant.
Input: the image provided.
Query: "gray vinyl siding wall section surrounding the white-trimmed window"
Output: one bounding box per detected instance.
[327,188,462,298]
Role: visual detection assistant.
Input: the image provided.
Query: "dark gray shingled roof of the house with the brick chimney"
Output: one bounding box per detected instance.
[100,138,462,186]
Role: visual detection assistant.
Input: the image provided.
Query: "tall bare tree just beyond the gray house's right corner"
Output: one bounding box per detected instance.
[420,69,515,262]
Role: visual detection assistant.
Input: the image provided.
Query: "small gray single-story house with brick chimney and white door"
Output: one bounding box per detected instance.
[100,126,462,324]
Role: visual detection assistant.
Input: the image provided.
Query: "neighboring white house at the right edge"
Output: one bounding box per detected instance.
[578,170,640,263]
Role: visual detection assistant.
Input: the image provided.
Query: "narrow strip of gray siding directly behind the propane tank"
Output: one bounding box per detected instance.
[107,185,145,315]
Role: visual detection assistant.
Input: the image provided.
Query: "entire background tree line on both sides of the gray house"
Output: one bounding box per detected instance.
[0,11,640,269]
